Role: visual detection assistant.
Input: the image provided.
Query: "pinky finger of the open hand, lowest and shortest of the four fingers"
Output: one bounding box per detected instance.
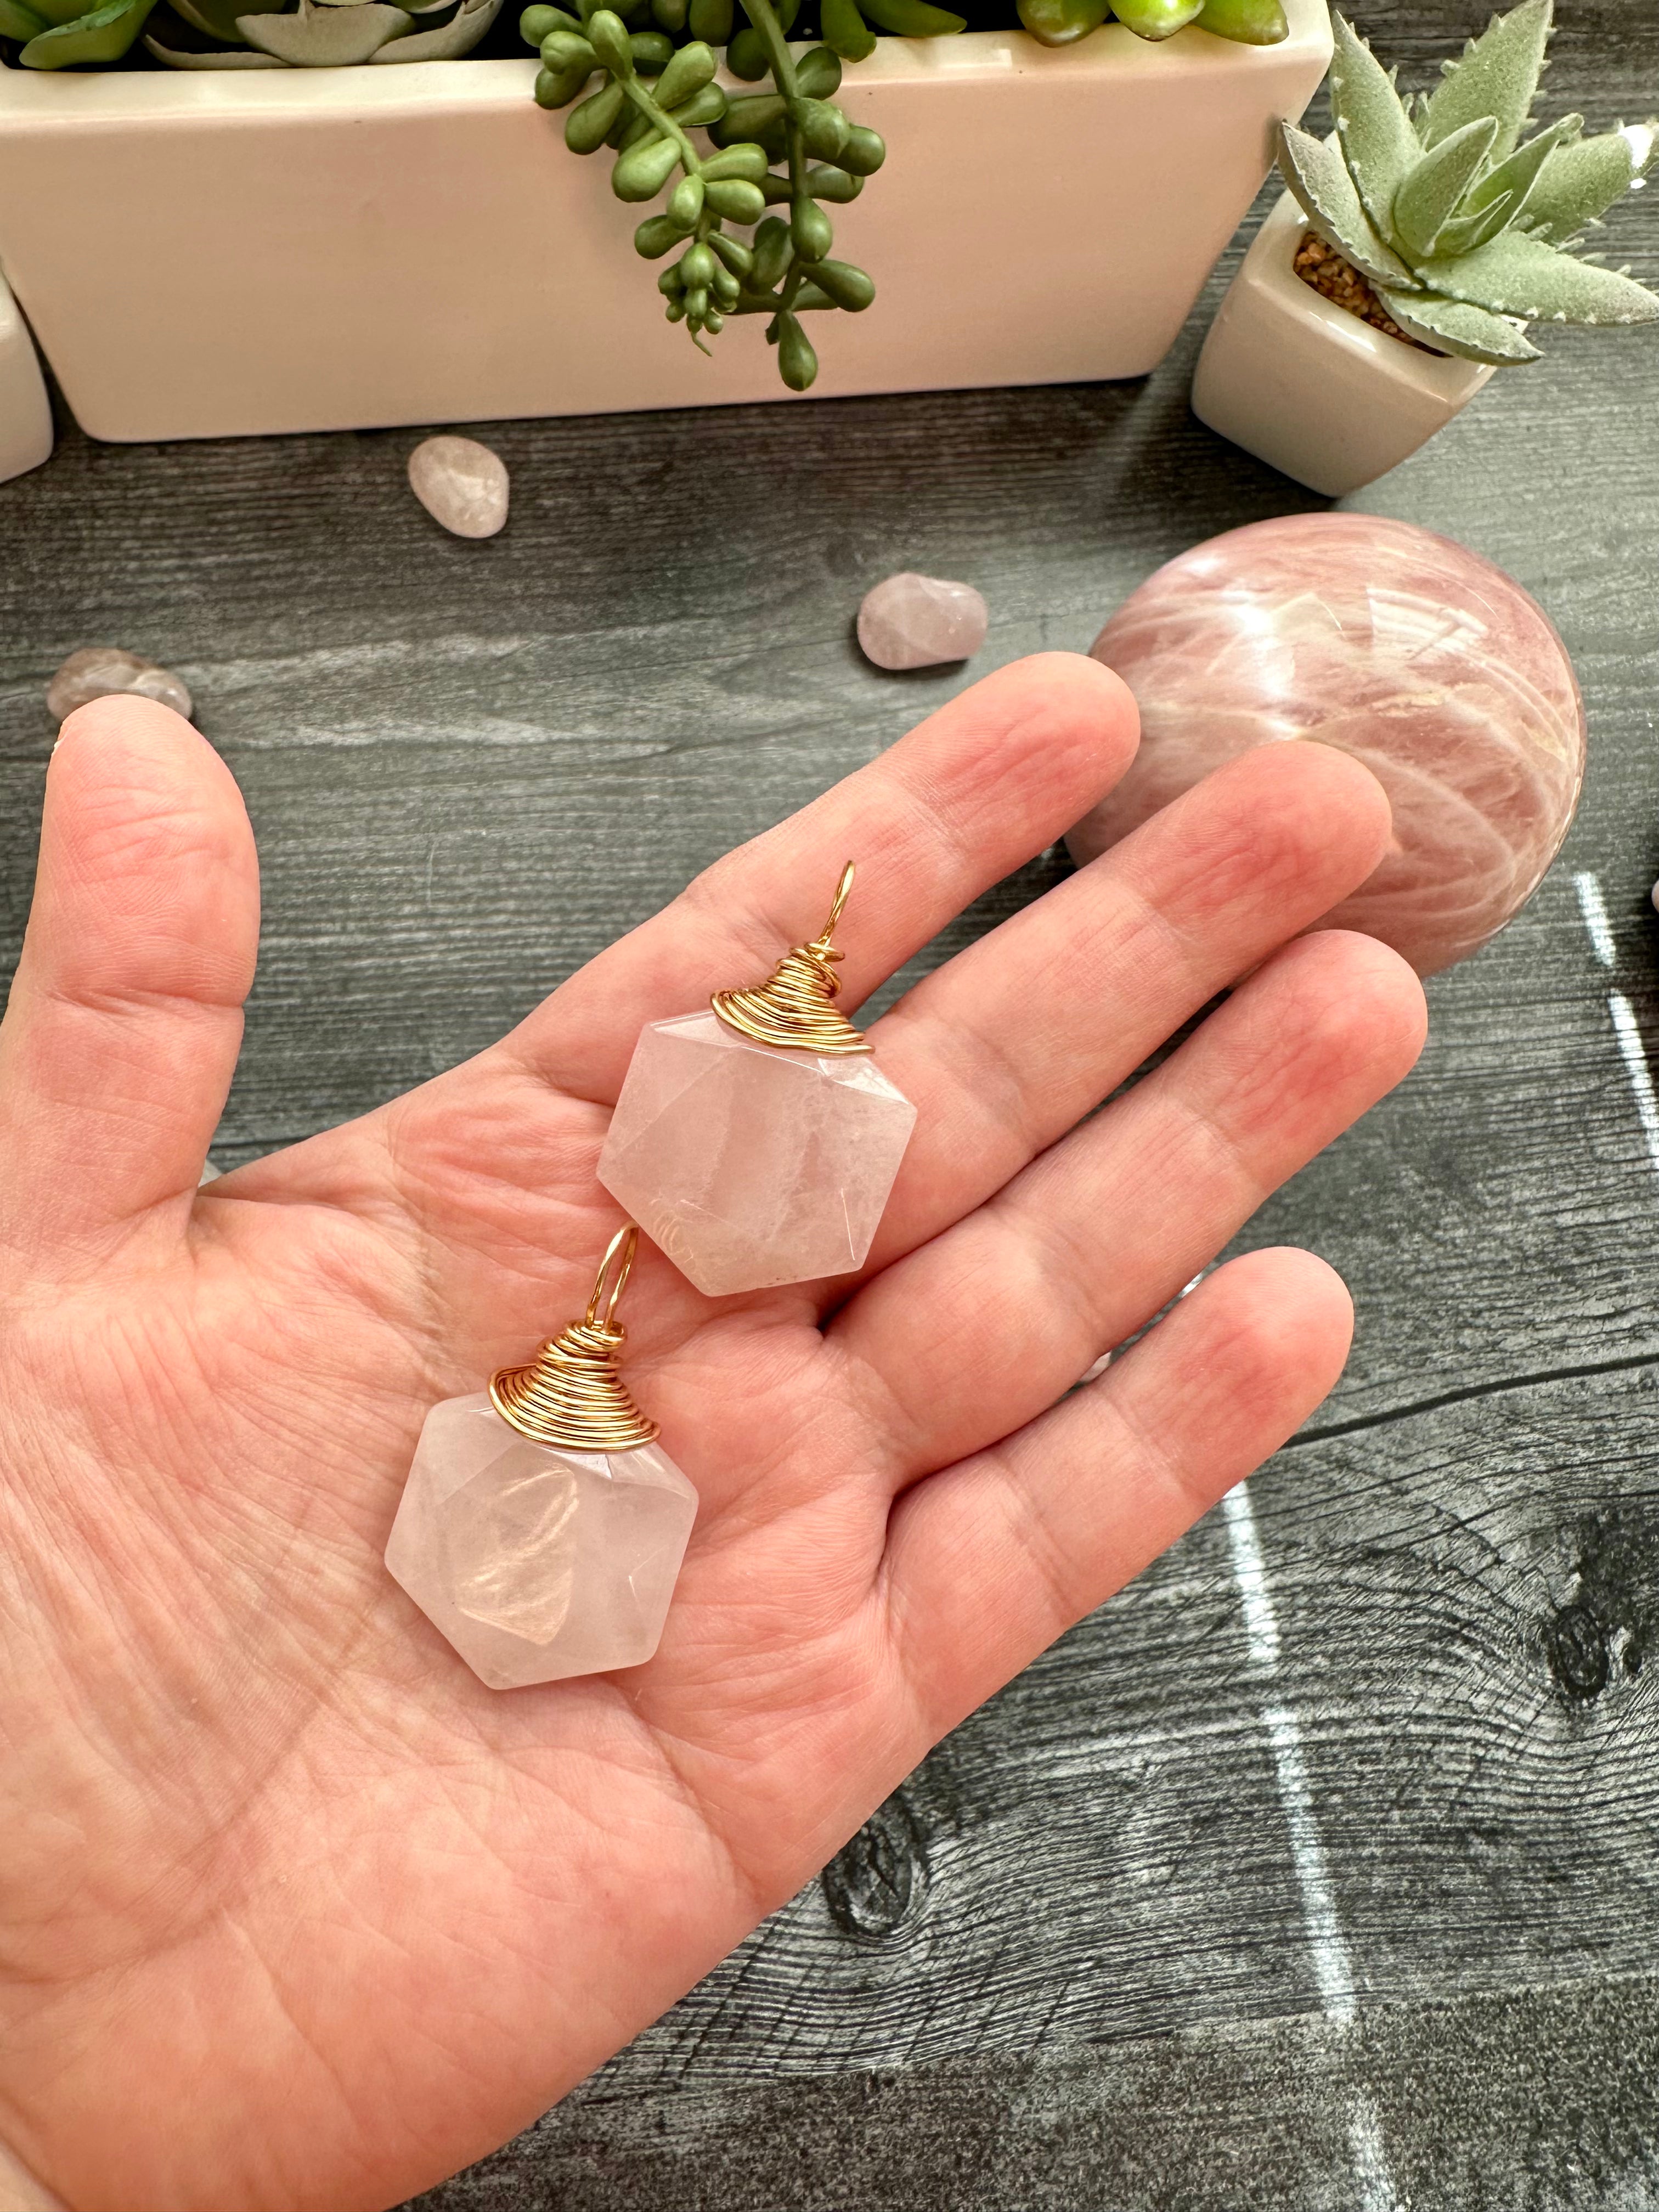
[883,1250,1354,1743]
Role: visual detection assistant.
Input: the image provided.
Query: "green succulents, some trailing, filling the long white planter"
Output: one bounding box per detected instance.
[0,0,1290,392]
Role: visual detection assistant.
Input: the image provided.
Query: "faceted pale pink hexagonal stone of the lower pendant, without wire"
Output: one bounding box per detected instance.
[385,1391,697,1690]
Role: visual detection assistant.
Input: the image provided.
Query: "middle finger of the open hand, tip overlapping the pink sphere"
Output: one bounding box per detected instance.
[865,743,1391,1274]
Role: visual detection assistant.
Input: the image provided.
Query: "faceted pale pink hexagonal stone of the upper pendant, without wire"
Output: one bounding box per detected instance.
[600,1013,916,1296]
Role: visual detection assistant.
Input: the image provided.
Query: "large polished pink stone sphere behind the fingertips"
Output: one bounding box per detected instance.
[1066,513,1584,975]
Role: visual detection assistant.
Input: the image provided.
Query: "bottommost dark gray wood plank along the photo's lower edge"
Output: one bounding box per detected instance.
[409,1980,1659,2212]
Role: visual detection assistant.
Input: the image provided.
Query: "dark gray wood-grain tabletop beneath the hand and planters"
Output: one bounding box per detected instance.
[0,0,1659,2212]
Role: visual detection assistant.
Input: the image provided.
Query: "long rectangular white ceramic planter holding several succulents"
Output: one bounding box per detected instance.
[0,0,1331,438]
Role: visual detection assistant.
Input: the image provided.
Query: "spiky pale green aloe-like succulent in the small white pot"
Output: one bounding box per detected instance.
[1278,0,1659,365]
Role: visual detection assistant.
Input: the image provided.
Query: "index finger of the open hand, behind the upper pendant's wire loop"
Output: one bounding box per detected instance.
[502,652,1139,1106]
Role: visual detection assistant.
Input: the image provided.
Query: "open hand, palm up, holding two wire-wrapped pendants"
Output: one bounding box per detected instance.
[0,657,1420,2212]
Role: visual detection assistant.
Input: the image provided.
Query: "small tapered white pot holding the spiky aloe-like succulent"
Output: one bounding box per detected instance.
[1192,193,1493,498]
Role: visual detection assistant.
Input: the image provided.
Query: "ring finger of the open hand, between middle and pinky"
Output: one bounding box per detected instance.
[830,931,1425,1484]
